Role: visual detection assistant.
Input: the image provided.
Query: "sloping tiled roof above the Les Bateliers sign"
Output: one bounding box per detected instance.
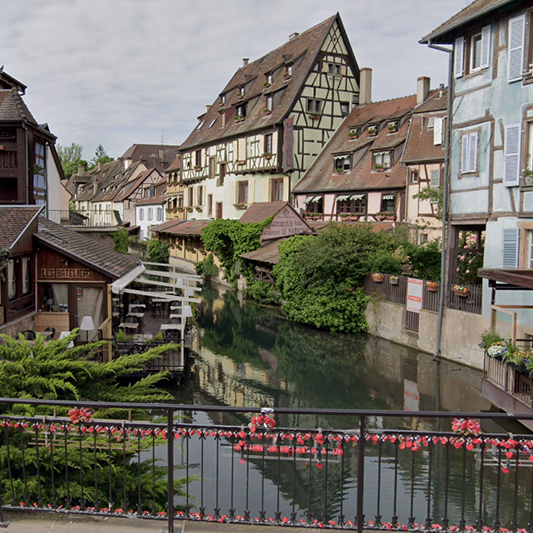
[35,217,141,279]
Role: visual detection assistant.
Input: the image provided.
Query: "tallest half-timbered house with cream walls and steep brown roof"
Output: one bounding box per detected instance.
[180,14,359,218]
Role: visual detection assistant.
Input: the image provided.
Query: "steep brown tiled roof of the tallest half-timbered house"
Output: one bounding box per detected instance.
[180,14,359,151]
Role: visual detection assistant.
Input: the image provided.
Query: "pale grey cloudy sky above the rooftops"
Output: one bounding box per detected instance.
[0,0,470,159]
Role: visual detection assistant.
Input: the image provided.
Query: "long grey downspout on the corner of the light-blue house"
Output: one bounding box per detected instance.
[428,41,454,358]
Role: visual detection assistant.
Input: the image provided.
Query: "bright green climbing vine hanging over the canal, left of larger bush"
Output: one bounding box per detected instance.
[202,217,272,284]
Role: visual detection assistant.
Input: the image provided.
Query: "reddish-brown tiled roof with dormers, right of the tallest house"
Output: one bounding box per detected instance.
[294,95,416,193]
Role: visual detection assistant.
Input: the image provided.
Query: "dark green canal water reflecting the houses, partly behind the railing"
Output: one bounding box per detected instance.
[169,286,531,525]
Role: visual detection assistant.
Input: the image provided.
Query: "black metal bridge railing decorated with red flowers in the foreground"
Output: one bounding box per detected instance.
[0,398,533,533]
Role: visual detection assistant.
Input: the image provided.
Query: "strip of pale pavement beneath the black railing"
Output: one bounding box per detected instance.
[0,512,294,533]
